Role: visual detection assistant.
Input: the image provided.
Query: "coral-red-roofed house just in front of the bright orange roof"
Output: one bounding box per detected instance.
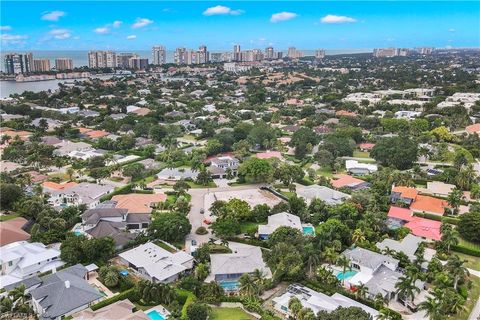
[388,206,442,241]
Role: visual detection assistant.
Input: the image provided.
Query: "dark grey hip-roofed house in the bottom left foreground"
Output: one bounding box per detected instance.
[30,264,103,320]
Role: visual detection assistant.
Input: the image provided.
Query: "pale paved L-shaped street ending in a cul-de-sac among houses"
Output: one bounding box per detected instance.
[185,181,259,252]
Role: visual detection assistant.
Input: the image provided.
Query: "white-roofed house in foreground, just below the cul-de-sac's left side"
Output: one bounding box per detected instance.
[119,242,193,283]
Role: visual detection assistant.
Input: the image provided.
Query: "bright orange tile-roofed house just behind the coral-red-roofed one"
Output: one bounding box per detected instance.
[390,187,450,215]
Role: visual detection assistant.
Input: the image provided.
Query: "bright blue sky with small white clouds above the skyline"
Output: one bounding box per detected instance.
[0,0,480,51]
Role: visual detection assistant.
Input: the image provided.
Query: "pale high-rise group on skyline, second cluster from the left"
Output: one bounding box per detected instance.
[88,51,148,70]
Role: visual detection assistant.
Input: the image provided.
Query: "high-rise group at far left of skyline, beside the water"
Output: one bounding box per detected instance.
[4,52,73,74]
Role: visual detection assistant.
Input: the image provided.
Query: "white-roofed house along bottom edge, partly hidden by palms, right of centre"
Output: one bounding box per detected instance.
[272,283,379,319]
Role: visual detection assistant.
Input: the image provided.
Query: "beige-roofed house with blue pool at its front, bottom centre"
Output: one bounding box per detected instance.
[205,242,272,292]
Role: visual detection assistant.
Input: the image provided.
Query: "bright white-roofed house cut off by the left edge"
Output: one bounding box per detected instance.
[0,241,64,288]
